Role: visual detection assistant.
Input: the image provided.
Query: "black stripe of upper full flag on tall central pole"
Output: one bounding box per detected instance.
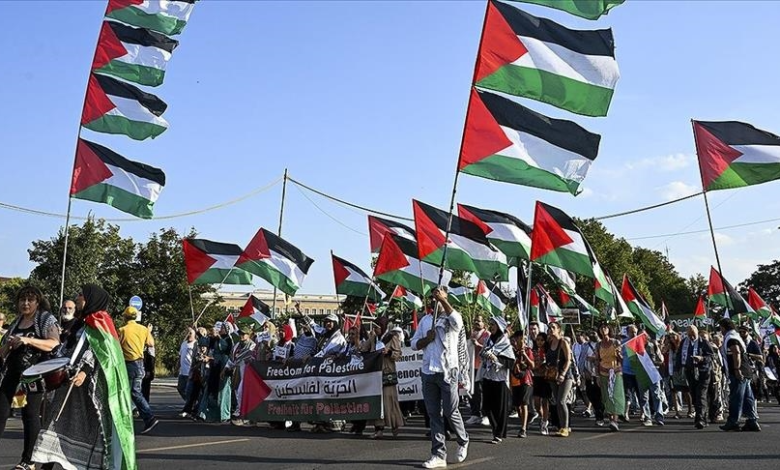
[491,0,615,57]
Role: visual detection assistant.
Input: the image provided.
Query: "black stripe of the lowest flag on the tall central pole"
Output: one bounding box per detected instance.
[477,90,601,161]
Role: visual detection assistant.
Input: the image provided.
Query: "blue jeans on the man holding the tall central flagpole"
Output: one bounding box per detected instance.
[421,373,469,459]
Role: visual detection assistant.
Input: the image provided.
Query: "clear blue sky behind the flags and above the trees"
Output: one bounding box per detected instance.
[0,0,780,293]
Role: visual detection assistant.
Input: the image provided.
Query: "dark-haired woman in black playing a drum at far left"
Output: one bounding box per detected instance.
[0,286,60,470]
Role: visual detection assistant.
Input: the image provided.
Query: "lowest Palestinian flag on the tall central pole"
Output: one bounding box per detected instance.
[458,89,601,195]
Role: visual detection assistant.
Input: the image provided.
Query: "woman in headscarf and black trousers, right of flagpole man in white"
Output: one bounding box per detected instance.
[476,317,515,444]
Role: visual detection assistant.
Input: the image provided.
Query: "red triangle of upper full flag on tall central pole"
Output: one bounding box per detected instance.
[474,2,528,83]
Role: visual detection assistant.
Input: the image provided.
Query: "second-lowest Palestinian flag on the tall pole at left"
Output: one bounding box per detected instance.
[81,74,168,140]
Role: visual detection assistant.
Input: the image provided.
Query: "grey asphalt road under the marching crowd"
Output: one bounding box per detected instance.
[0,386,780,470]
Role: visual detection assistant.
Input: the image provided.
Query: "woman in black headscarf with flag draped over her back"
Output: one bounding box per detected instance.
[33,284,137,470]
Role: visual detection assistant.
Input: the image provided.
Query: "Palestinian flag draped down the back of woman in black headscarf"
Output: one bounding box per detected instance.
[84,311,138,470]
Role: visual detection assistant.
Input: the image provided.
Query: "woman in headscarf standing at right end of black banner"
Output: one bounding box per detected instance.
[372,322,404,439]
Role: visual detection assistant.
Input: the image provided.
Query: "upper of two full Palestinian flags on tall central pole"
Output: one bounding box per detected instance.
[474,0,620,116]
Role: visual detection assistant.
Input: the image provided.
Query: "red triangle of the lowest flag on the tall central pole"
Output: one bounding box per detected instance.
[458,88,512,170]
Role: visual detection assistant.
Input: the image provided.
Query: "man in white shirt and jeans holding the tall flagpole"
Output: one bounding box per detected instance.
[412,287,469,468]
